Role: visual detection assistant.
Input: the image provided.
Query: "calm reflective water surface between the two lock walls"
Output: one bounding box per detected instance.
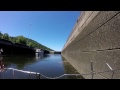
[0,54,83,79]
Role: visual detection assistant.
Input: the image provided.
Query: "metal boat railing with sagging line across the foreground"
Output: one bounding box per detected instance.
[0,61,120,79]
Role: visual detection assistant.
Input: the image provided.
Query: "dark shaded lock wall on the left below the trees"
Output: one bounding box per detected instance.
[0,39,35,55]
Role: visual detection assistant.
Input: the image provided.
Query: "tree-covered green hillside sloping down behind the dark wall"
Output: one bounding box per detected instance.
[0,32,54,51]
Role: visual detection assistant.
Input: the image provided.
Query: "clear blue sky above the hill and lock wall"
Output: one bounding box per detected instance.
[0,11,80,51]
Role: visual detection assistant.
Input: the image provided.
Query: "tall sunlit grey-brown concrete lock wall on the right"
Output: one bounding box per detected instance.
[62,11,120,79]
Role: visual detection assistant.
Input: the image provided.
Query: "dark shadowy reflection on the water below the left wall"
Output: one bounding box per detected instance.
[3,55,36,69]
